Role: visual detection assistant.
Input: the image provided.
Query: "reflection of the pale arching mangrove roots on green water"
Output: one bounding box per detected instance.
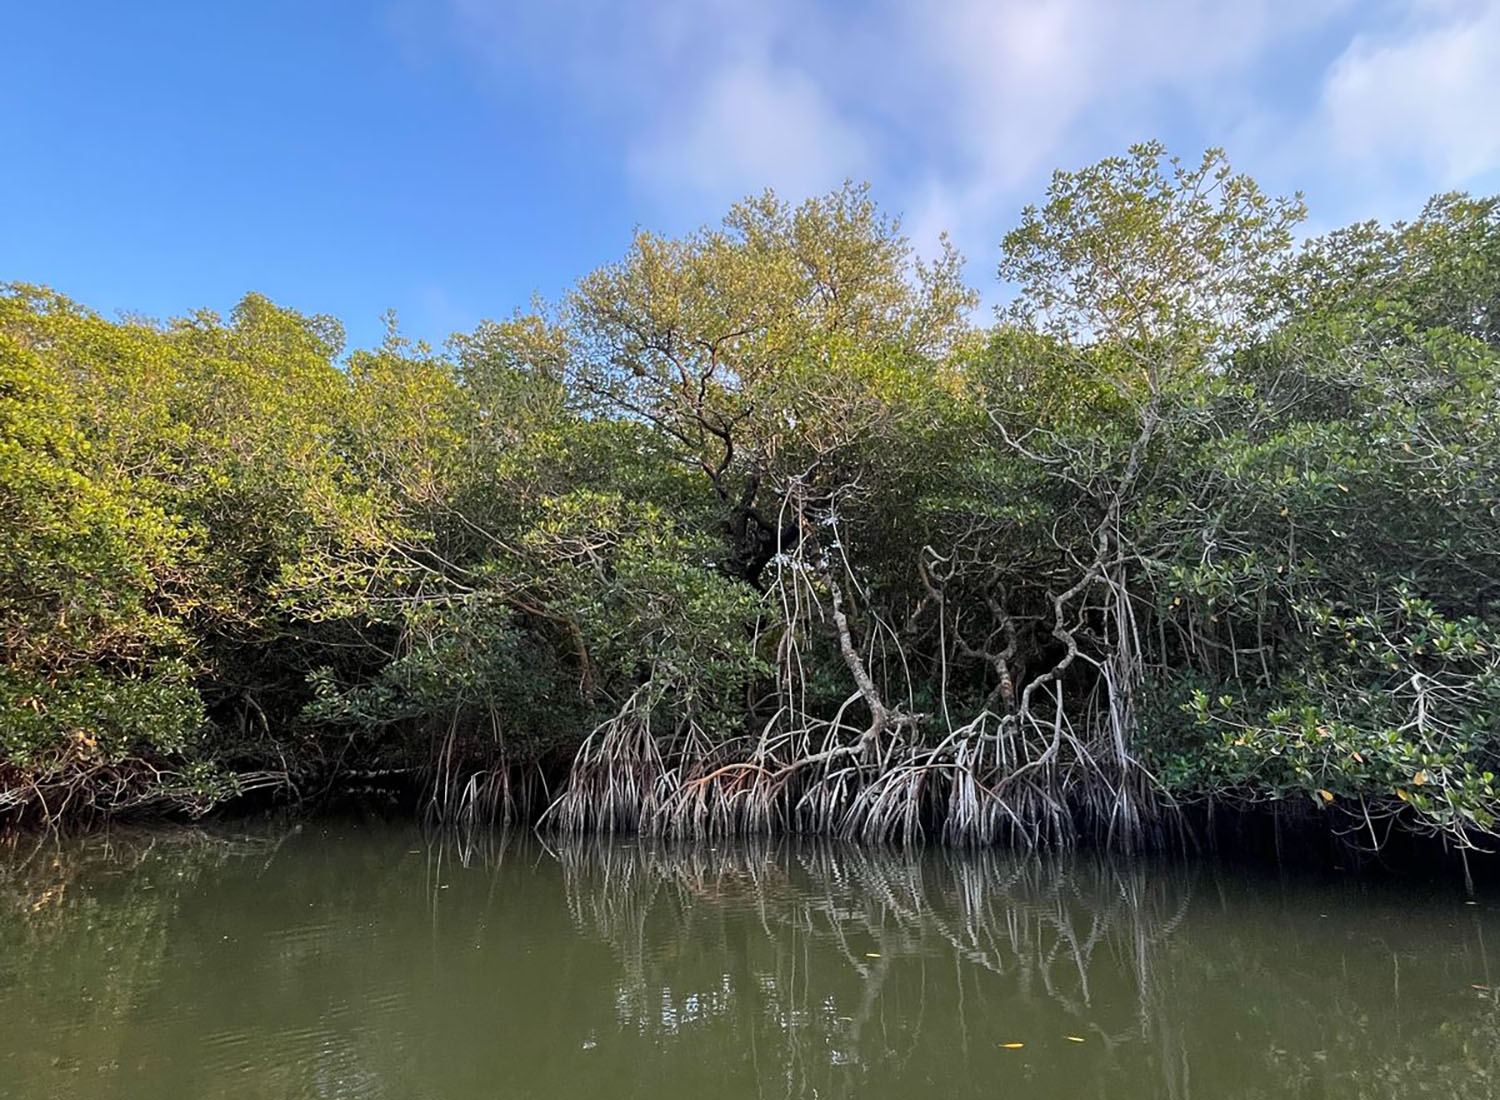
[543,845,1194,1095]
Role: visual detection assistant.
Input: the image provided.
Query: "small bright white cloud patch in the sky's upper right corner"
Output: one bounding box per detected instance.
[1322,2,1500,189]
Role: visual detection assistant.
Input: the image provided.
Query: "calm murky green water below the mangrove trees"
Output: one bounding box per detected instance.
[0,825,1500,1100]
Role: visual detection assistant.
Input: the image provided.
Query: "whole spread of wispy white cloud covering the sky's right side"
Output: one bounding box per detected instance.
[417,0,1500,274]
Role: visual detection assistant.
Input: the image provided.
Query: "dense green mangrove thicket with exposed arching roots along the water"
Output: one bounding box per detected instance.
[0,146,1500,848]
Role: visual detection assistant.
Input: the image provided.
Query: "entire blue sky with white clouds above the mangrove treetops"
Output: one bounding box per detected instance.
[0,0,1500,344]
